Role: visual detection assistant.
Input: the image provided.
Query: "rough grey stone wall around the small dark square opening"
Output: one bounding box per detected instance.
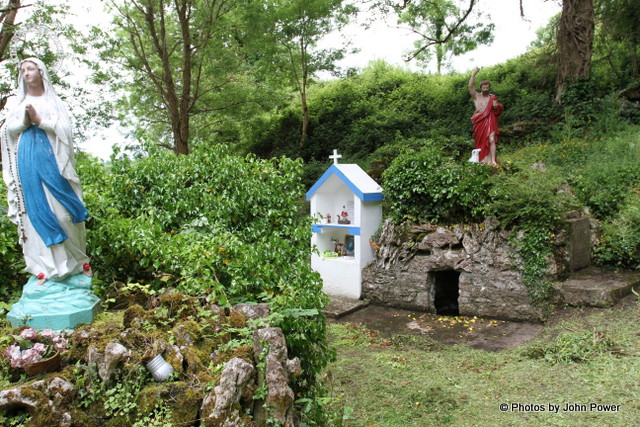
[362,218,584,320]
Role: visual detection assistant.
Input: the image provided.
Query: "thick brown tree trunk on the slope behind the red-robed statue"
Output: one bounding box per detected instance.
[556,0,594,102]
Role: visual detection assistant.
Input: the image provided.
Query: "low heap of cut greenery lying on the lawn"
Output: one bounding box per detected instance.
[523,329,616,364]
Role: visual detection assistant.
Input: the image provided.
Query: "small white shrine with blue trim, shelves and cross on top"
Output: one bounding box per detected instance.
[307,150,383,299]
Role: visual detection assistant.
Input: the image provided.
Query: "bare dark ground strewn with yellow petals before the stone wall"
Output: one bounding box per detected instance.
[331,305,544,351]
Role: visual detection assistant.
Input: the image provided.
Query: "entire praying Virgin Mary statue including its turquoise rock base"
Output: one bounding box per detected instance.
[0,58,99,329]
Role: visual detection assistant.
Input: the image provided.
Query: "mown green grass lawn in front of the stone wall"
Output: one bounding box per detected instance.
[326,296,640,427]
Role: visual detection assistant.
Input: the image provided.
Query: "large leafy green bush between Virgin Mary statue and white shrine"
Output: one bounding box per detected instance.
[78,147,332,412]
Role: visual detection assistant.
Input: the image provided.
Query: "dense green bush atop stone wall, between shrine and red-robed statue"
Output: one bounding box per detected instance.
[383,142,490,224]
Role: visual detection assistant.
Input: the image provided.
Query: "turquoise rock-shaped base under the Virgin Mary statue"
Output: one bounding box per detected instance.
[7,274,100,331]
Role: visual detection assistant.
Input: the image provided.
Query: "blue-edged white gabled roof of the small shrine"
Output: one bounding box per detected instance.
[307,164,384,202]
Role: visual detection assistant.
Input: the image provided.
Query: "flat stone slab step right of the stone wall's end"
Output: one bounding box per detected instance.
[555,267,640,307]
